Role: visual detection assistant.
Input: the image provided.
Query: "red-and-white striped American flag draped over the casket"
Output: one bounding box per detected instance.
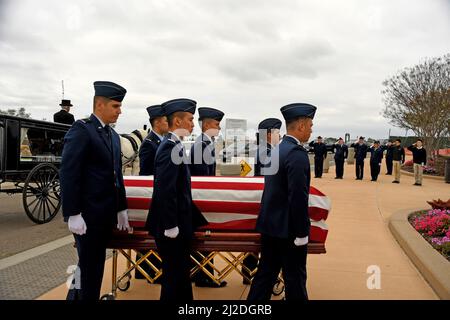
[124,176,331,243]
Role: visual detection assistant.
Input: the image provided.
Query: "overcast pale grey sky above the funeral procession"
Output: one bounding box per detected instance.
[0,0,450,138]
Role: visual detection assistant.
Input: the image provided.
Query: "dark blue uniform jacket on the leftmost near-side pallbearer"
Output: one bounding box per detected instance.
[59,115,127,228]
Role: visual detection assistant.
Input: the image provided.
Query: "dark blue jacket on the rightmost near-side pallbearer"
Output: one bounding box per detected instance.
[256,136,311,238]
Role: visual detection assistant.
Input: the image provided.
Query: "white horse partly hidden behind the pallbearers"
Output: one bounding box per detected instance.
[120,129,150,176]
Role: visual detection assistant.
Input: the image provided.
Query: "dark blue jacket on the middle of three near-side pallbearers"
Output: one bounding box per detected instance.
[146,133,207,238]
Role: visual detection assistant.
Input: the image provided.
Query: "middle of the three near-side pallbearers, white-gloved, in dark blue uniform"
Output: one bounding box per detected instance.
[146,99,207,302]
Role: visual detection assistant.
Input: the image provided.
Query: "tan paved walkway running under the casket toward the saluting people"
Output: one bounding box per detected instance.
[7,161,450,299]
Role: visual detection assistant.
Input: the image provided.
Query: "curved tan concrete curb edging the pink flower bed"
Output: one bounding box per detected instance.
[389,209,450,300]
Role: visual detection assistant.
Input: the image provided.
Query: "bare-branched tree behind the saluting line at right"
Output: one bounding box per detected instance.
[382,54,450,162]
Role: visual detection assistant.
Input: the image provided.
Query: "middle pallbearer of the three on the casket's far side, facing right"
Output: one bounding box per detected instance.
[189,107,227,288]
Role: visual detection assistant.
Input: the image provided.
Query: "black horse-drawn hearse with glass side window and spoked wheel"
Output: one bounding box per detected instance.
[0,114,70,223]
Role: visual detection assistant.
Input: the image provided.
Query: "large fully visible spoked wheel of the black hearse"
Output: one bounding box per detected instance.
[22,163,61,224]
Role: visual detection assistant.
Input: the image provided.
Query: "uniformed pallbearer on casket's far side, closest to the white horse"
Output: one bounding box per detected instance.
[135,105,169,282]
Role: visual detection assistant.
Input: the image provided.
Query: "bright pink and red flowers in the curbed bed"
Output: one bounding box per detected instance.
[410,209,450,259]
